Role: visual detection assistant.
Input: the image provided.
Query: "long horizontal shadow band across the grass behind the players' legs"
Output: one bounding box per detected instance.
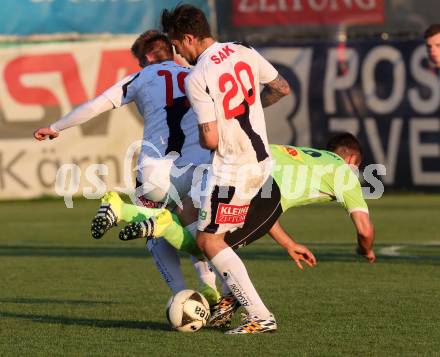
[0,243,440,264]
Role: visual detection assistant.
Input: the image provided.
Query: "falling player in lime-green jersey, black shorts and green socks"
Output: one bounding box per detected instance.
[95,133,376,326]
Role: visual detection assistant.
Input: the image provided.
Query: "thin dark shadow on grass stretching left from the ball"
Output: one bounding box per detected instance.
[0,311,172,331]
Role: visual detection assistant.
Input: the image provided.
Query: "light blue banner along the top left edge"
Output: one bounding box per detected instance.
[0,0,209,36]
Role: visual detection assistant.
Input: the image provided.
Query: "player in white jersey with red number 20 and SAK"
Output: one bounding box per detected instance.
[161,5,290,334]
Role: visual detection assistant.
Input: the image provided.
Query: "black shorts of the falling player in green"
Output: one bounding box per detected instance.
[225,177,283,249]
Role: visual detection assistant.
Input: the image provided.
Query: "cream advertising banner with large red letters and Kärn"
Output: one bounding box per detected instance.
[0,41,142,200]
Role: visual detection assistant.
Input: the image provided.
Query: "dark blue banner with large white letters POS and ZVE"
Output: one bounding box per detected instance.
[260,40,440,190]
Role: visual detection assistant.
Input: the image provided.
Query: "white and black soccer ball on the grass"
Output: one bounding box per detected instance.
[166,290,209,332]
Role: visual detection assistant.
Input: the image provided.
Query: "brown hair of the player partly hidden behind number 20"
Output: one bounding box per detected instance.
[131,30,173,67]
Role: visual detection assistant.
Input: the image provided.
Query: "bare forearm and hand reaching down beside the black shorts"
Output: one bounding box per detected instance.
[269,221,316,269]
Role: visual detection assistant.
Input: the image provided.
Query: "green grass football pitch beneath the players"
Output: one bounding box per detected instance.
[0,195,440,356]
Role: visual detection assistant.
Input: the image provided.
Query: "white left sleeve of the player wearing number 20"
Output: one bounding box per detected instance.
[185,72,217,124]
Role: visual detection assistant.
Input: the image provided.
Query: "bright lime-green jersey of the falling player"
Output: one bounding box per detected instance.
[270,145,368,213]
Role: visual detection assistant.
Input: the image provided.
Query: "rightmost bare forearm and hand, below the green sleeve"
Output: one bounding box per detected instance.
[350,211,376,263]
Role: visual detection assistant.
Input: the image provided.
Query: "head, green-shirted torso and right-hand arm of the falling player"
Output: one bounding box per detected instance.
[271,133,376,263]
